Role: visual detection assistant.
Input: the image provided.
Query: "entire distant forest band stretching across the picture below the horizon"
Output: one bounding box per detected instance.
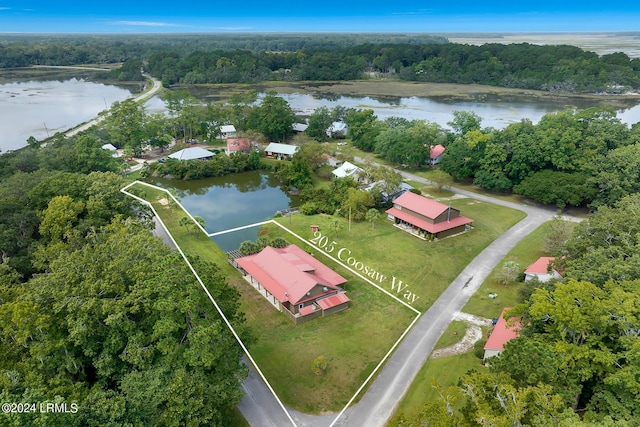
[0,34,640,93]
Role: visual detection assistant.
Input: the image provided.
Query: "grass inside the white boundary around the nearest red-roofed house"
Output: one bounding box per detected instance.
[124,184,416,413]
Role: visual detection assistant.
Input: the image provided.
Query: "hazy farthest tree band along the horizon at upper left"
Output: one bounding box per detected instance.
[0,33,447,68]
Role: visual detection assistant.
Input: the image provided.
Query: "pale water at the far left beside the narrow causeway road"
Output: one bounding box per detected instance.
[0,77,136,152]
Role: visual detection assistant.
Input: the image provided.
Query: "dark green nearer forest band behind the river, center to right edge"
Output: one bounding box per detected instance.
[148,43,640,93]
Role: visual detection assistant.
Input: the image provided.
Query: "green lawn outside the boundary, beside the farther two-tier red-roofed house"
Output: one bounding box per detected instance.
[262,198,525,312]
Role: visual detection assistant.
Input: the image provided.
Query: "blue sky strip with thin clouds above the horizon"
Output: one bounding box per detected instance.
[0,0,640,33]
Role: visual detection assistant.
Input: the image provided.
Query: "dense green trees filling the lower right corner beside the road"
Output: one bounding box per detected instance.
[390,193,640,427]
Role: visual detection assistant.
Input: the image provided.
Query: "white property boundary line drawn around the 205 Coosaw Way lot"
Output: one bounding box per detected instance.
[120,181,422,427]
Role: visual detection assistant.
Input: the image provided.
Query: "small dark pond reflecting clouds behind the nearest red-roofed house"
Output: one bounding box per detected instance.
[150,171,299,251]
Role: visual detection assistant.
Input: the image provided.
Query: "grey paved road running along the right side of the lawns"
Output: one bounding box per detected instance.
[239,158,578,427]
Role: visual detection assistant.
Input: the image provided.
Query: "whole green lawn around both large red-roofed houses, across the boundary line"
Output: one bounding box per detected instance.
[125,182,524,413]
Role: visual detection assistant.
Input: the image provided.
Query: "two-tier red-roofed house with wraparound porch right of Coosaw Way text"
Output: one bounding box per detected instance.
[386,191,473,239]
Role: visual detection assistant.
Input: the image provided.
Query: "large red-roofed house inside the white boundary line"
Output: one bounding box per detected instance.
[234,245,349,324]
